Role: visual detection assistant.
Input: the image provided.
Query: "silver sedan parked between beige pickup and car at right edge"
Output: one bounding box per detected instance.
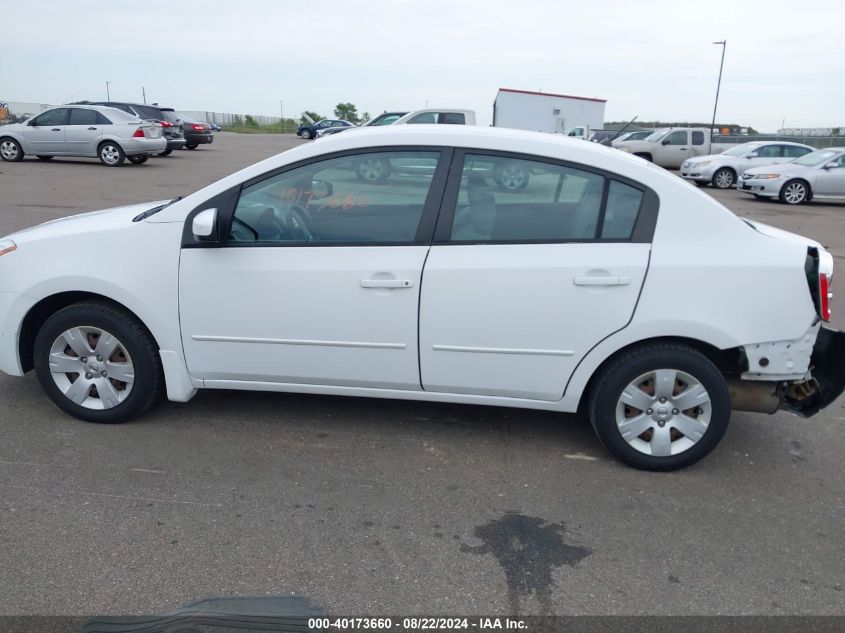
[681,141,815,189]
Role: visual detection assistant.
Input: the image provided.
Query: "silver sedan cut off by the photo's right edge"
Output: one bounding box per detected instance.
[738,147,845,204]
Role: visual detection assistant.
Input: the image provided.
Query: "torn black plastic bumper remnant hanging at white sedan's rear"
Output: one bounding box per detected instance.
[781,327,845,418]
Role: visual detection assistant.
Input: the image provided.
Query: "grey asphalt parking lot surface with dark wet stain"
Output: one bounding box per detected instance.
[0,134,845,615]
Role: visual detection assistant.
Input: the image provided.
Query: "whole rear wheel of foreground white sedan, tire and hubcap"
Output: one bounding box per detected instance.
[589,343,731,471]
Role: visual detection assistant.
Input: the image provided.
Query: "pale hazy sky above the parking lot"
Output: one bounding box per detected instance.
[0,0,845,131]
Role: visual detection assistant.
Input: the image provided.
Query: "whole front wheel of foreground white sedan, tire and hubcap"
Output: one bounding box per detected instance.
[33,302,163,423]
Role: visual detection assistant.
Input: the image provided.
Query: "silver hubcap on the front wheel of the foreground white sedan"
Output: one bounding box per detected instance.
[50,326,135,410]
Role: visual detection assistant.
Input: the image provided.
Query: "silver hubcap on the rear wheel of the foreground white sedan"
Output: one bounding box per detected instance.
[616,369,713,457]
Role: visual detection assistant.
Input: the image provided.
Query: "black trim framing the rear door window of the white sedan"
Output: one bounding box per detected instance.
[433,148,660,246]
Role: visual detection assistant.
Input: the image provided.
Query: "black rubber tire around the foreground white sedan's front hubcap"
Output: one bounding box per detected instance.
[33,301,164,424]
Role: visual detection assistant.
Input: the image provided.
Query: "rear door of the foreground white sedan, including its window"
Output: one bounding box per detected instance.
[420,151,657,401]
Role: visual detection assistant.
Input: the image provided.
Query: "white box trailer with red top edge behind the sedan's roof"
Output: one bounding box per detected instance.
[493,88,607,134]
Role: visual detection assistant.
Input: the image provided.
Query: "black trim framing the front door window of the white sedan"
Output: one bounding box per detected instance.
[182,145,454,248]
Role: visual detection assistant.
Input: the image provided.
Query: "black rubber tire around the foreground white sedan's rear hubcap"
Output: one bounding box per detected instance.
[588,343,731,471]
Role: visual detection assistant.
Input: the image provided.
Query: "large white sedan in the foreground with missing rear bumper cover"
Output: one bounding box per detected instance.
[0,126,845,470]
